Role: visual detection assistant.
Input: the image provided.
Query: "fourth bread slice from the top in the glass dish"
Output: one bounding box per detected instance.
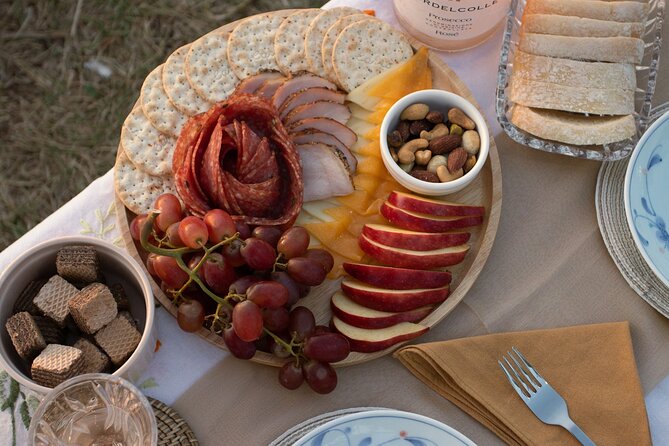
[513,51,636,90]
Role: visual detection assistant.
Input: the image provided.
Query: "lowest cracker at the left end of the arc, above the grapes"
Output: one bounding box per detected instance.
[114,152,176,214]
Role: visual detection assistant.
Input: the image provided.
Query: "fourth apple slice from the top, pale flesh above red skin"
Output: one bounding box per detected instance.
[358,234,469,269]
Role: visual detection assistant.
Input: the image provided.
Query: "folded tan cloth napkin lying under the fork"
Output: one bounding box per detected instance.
[395,322,651,446]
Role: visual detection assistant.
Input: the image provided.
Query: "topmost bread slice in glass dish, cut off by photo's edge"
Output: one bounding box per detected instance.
[525,0,648,22]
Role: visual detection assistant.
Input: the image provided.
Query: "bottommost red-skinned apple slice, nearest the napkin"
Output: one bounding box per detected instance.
[331,316,429,353]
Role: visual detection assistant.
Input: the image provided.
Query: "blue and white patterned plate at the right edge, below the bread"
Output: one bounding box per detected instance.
[625,113,669,286]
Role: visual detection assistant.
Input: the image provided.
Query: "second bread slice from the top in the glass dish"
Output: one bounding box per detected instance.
[523,14,643,37]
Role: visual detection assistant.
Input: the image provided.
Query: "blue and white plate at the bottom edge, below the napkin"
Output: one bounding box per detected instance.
[295,409,476,446]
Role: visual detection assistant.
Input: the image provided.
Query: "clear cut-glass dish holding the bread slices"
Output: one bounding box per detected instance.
[495,0,665,161]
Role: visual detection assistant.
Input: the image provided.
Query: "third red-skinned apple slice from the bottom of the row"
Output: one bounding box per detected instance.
[341,279,449,312]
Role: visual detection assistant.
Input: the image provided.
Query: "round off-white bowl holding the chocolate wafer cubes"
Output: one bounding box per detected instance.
[0,236,156,394]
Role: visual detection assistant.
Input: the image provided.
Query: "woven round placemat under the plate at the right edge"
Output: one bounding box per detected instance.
[595,103,669,318]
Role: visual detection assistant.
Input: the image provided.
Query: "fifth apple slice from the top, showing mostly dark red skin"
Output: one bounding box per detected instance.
[343,262,451,290]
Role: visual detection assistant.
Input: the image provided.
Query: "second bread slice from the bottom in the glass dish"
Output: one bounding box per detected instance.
[509,76,634,115]
